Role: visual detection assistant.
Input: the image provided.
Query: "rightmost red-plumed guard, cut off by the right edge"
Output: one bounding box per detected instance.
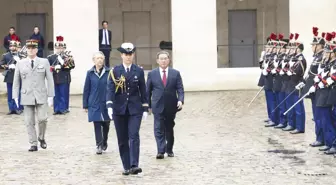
[311,33,336,154]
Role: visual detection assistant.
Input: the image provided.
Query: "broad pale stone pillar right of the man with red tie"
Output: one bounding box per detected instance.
[171,0,217,90]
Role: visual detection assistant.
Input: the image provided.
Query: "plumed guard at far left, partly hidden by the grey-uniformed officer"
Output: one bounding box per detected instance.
[0,37,23,115]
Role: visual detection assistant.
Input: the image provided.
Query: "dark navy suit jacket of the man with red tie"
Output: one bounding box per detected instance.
[146,68,184,114]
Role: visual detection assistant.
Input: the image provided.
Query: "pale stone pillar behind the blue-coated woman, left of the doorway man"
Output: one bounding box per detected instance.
[53,0,99,94]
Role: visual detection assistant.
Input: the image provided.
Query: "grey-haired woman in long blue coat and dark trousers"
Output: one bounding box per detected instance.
[83,52,111,155]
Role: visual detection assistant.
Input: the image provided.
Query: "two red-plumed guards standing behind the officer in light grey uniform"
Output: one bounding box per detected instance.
[0,36,75,115]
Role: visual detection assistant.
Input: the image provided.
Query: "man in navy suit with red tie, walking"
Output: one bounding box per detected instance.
[147,51,184,159]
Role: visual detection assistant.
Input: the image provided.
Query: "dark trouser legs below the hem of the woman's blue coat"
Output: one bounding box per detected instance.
[93,121,110,146]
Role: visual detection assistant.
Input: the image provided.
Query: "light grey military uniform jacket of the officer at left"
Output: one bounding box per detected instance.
[12,57,55,105]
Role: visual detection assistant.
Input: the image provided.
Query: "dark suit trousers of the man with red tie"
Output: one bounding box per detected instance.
[154,112,176,154]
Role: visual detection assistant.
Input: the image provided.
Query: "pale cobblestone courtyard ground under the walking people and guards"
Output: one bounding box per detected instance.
[0,91,336,185]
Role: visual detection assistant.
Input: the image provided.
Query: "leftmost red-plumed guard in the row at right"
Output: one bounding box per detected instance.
[262,33,277,126]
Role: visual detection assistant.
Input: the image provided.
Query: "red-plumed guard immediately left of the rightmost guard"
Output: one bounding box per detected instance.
[297,27,325,147]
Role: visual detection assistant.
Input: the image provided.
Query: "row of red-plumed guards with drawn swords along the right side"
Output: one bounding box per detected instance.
[258,27,336,155]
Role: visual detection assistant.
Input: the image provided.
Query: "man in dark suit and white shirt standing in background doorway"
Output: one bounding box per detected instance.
[99,21,112,67]
